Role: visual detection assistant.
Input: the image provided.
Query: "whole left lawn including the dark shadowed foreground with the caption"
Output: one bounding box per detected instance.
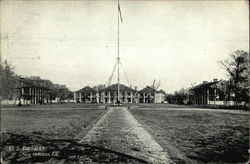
[0,104,148,163]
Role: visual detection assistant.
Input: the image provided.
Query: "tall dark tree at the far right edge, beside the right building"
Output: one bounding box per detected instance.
[220,50,249,105]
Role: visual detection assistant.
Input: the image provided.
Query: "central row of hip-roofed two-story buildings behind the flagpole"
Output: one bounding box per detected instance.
[74,84,166,104]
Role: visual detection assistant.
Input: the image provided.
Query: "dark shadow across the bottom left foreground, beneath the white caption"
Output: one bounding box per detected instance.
[1,133,147,163]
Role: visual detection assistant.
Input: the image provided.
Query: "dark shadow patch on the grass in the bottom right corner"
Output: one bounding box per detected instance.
[188,126,249,163]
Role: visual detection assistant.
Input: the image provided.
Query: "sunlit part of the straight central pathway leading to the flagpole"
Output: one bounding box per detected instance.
[81,107,171,163]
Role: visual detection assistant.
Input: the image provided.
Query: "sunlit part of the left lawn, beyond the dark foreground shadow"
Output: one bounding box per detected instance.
[1,104,105,139]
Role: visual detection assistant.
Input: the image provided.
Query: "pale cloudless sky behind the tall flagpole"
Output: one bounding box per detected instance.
[0,0,249,93]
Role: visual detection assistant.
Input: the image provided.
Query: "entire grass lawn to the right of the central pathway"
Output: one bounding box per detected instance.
[130,105,249,163]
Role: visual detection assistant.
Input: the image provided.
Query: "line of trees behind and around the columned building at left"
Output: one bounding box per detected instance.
[0,60,74,100]
